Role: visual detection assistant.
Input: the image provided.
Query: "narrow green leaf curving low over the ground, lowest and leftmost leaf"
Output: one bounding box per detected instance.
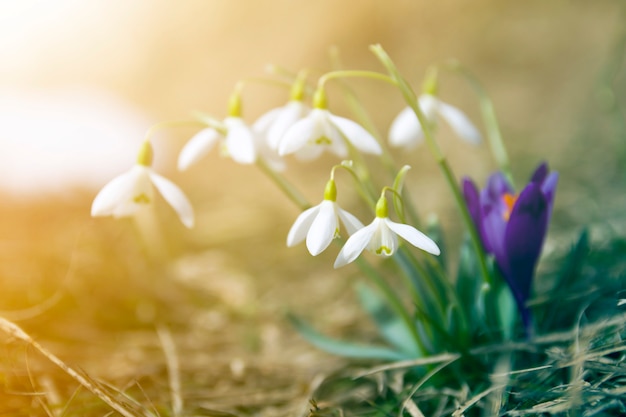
[287,313,411,361]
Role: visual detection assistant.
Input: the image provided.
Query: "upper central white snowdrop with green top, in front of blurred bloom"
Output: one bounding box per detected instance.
[278,89,382,160]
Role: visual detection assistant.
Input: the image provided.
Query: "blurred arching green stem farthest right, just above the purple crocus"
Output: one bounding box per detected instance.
[446,61,515,188]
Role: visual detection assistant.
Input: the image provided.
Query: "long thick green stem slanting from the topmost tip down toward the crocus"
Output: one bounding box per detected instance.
[370,45,492,287]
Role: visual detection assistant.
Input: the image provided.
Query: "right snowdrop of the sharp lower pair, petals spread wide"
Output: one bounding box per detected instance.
[334,196,441,268]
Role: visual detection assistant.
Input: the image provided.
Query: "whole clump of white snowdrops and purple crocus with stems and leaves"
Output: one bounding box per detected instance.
[91,45,558,359]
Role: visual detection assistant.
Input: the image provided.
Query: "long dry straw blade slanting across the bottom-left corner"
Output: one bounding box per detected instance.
[0,317,152,417]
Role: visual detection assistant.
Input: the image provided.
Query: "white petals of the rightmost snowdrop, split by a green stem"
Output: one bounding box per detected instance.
[389,93,482,148]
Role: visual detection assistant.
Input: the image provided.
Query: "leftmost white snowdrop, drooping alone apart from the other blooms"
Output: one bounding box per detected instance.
[91,141,194,228]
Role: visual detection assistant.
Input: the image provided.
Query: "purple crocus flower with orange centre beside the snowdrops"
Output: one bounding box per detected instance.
[463,163,559,334]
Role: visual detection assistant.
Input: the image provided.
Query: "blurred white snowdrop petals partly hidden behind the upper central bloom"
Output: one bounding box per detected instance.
[252,100,311,152]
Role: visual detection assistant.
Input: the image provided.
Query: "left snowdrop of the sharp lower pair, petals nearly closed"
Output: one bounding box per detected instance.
[287,179,363,256]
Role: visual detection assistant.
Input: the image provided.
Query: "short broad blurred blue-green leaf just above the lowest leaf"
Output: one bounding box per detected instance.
[356,283,422,358]
